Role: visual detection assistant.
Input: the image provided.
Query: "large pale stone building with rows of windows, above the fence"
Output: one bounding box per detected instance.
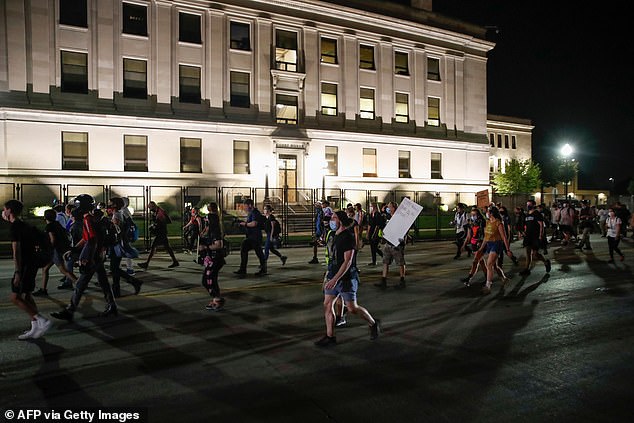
[0,0,494,211]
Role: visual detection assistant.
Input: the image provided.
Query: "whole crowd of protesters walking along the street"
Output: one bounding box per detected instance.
[2,194,634,347]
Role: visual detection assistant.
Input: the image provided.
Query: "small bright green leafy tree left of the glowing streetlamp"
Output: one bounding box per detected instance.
[493,159,542,195]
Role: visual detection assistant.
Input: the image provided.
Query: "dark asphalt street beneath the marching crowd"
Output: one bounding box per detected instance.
[0,235,634,422]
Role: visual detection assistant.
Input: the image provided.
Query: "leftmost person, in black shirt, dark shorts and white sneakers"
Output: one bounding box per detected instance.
[2,200,51,340]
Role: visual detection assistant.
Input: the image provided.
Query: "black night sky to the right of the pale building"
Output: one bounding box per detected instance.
[396,0,634,190]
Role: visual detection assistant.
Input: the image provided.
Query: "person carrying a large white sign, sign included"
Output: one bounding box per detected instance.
[375,198,423,289]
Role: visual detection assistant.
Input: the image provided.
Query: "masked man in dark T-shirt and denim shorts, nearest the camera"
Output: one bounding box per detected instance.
[315,211,380,347]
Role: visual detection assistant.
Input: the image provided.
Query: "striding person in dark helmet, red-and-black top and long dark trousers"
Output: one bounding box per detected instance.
[51,194,118,321]
